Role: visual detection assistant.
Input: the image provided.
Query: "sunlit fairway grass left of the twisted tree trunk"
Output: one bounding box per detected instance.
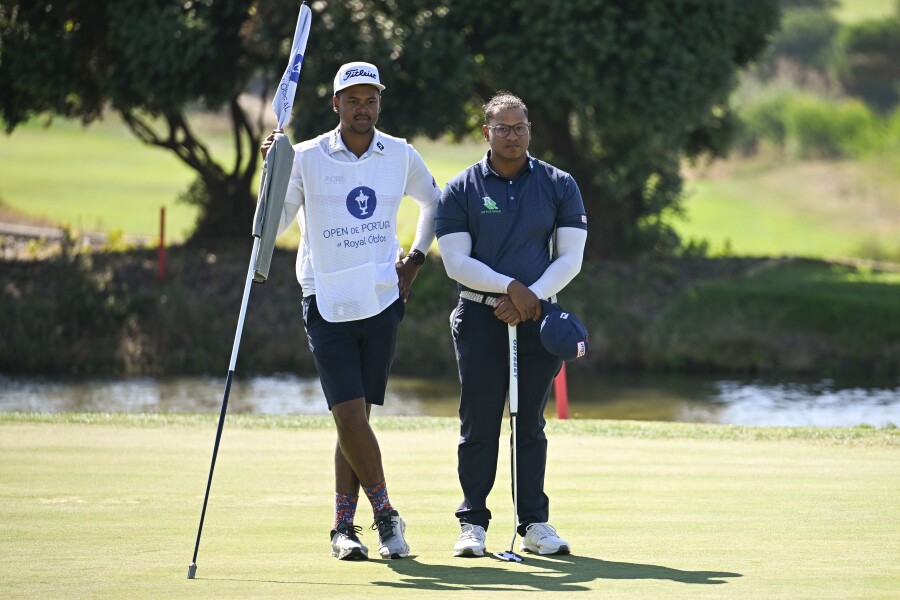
[0,119,197,239]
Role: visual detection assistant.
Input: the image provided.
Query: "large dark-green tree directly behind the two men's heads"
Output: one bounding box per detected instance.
[295,0,779,257]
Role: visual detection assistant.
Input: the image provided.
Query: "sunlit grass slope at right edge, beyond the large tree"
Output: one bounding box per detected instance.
[671,159,900,258]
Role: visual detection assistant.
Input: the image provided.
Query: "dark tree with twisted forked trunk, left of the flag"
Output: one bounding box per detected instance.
[0,0,280,237]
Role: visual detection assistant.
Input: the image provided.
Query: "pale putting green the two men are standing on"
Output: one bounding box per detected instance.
[0,414,900,599]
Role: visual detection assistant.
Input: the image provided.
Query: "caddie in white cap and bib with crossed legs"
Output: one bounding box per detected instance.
[261,62,441,560]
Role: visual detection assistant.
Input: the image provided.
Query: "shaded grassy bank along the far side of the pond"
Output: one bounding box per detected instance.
[0,244,900,377]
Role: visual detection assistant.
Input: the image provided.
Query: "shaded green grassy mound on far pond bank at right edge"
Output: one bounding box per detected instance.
[648,262,900,375]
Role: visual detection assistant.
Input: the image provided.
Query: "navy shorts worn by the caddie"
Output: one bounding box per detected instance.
[303,296,406,410]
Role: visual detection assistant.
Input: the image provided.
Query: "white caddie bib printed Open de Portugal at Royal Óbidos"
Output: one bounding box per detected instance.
[298,134,408,322]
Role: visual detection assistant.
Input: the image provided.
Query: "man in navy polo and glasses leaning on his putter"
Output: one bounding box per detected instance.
[435,92,587,556]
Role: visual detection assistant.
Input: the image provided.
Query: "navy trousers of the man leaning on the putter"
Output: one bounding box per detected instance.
[451,299,562,530]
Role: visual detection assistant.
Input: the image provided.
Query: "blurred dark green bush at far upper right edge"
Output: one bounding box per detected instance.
[835,16,900,113]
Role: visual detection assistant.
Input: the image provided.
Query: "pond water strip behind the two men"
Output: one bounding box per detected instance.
[0,372,900,427]
